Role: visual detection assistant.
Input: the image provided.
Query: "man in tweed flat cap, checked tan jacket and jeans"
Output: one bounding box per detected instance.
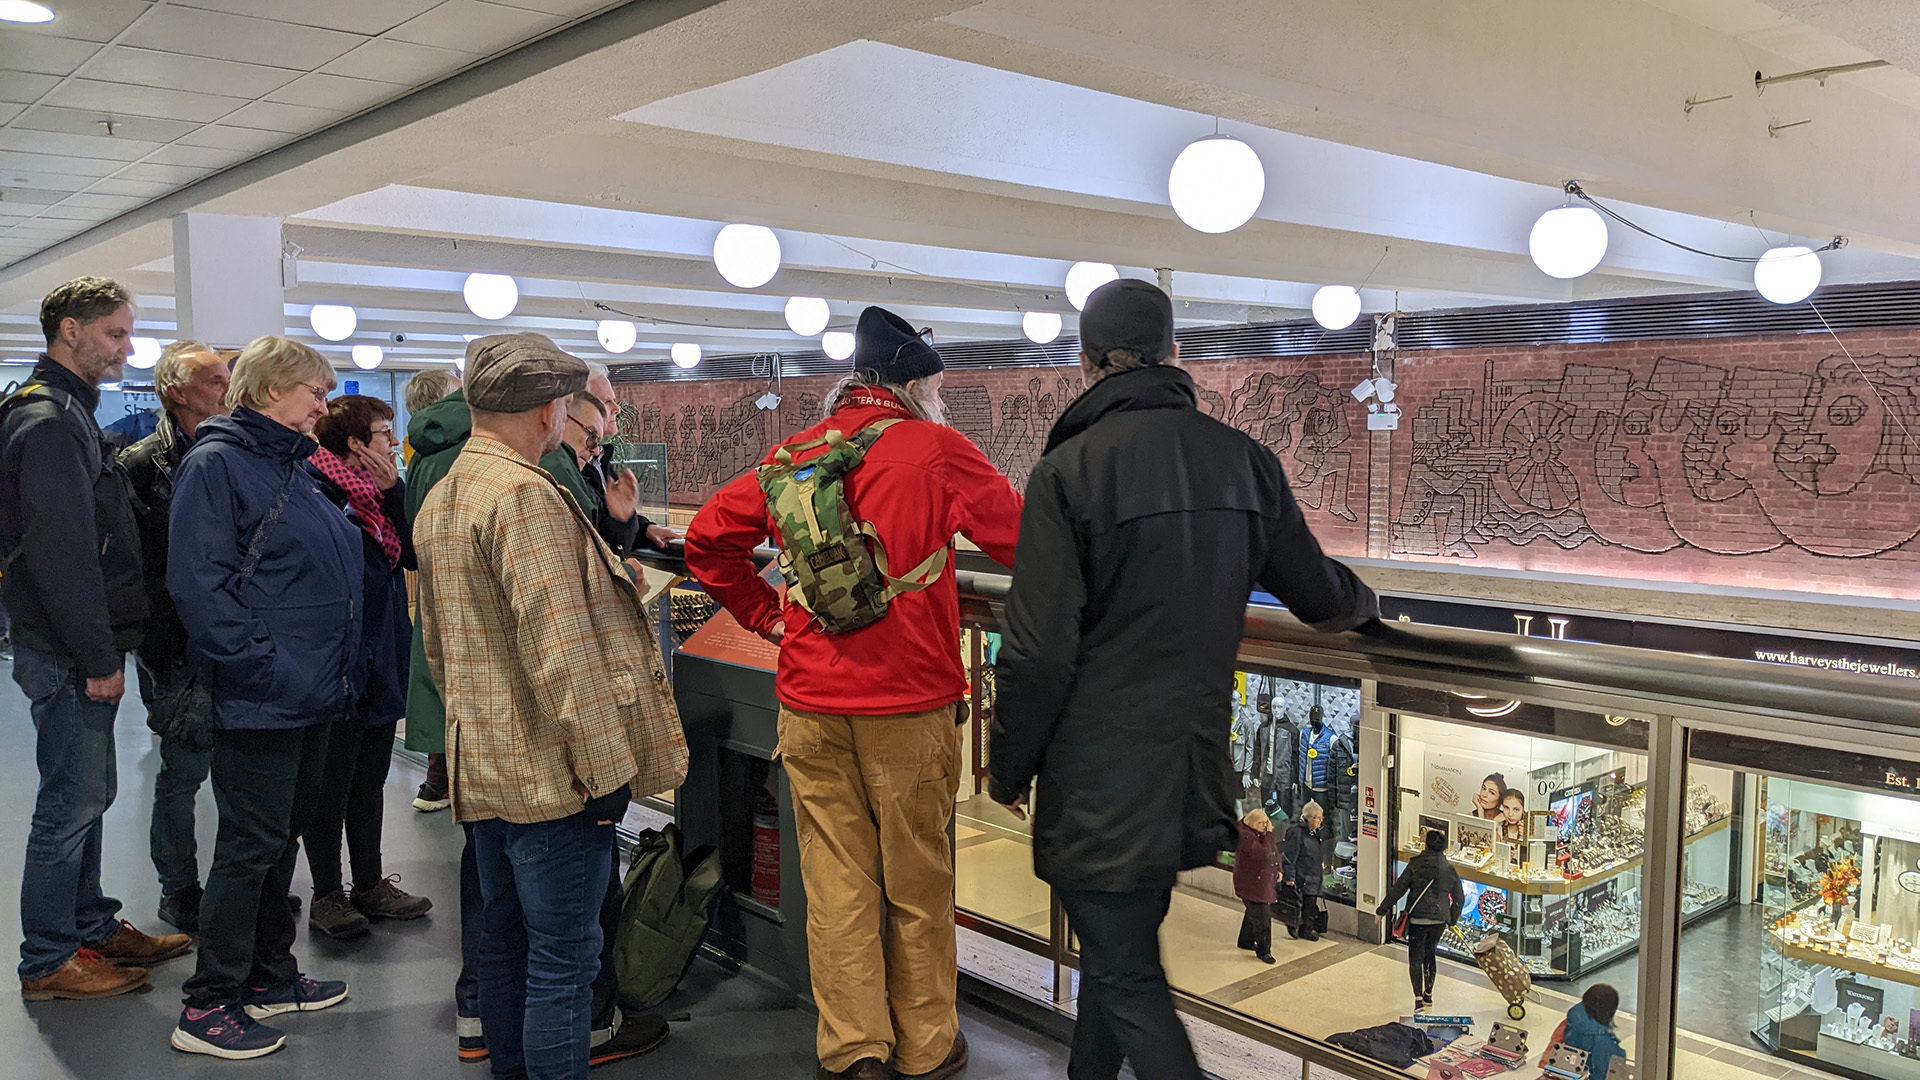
[415,334,687,1080]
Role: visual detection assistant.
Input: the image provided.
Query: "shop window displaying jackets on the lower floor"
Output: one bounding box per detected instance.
[1233,669,1359,905]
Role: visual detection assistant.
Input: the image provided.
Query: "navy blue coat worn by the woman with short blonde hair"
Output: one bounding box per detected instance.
[167,409,365,730]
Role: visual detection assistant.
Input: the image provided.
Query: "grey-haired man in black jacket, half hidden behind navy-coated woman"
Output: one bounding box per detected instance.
[121,342,230,934]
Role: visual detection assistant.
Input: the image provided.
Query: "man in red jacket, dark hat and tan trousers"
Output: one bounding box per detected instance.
[687,299,1021,1080]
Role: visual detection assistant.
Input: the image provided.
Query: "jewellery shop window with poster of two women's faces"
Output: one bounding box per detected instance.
[1394,713,1736,980]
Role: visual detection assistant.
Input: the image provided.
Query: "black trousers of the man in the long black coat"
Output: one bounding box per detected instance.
[1060,888,1200,1080]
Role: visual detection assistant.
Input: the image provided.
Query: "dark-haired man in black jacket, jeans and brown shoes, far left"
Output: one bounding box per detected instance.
[0,277,192,1001]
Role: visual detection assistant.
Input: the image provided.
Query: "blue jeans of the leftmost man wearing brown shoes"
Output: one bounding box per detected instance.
[13,644,125,978]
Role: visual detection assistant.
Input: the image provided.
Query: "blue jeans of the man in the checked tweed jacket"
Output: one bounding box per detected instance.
[472,813,612,1080]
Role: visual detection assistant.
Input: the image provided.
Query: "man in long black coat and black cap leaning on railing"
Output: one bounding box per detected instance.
[989,281,1379,1080]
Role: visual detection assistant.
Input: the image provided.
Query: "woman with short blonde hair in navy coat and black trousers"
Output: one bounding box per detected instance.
[167,336,363,1059]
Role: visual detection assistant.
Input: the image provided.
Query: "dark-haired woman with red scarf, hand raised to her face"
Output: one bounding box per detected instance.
[305,394,434,938]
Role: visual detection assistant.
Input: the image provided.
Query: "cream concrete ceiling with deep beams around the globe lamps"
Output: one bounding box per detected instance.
[0,0,1920,363]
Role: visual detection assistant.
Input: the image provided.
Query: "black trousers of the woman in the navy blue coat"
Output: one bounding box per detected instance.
[182,724,332,1009]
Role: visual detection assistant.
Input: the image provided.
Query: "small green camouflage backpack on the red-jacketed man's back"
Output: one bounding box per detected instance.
[755,413,947,634]
